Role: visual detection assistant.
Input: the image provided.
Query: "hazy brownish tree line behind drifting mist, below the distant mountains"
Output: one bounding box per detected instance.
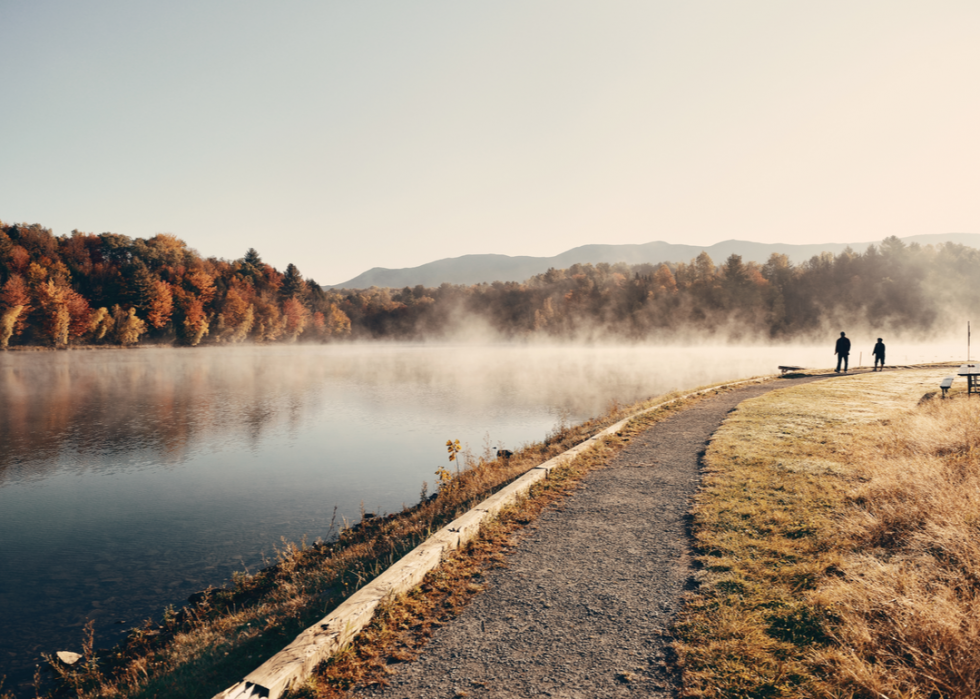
[341,237,980,341]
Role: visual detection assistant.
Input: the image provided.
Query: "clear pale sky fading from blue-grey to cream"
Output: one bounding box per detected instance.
[0,0,980,284]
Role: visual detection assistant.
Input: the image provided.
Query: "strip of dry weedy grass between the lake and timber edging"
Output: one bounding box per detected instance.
[36,382,736,699]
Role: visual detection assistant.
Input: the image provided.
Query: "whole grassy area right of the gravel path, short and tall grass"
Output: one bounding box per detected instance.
[676,368,980,697]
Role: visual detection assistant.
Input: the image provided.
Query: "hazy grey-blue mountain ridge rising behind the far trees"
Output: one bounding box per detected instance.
[327,233,980,289]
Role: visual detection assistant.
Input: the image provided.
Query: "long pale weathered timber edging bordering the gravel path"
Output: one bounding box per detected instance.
[214,375,775,699]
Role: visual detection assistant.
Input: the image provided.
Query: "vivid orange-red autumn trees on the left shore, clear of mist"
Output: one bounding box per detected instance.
[0,224,350,349]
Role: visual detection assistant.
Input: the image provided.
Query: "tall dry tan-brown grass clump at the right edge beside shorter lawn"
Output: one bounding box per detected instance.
[813,398,980,698]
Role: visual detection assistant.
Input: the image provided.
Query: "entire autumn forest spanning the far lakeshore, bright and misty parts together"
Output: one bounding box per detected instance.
[0,223,980,349]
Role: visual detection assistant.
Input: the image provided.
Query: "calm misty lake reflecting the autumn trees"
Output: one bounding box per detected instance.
[0,340,954,687]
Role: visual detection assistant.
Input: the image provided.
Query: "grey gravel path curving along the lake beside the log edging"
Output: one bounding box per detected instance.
[359,378,813,699]
